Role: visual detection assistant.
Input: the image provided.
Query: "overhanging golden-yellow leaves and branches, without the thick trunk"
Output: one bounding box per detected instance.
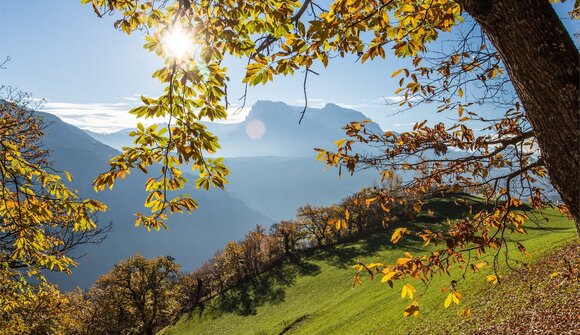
[83,0,566,315]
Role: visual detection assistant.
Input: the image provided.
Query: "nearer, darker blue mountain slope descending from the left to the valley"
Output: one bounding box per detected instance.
[39,113,273,289]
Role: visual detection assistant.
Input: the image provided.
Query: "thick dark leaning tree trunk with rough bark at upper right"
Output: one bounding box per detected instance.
[457,0,580,234]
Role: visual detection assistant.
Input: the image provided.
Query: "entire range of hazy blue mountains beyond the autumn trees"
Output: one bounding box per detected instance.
[42,101,380,289]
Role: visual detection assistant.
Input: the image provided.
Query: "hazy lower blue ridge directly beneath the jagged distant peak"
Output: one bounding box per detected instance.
[225,157,378,221]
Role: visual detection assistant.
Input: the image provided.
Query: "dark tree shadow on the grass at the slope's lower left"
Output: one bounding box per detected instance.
[208,255,320,317]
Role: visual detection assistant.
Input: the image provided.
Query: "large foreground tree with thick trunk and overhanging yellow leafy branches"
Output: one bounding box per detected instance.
[84,0,580,315]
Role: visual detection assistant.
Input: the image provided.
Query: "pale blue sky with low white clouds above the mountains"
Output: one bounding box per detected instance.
[0,0,571,132]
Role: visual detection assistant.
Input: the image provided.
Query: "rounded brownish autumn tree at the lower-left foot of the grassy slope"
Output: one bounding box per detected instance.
[86,254,179,335]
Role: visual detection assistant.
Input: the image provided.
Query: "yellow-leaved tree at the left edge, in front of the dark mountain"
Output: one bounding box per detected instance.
[0,86,110,326]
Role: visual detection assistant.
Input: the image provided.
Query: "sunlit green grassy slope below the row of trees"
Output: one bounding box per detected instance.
[161,199,576,335]
